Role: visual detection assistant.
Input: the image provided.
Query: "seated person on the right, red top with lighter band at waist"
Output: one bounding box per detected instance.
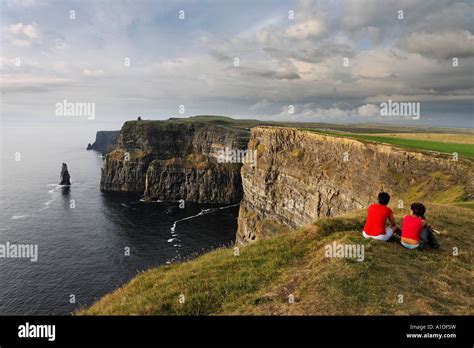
[401,203,439,250]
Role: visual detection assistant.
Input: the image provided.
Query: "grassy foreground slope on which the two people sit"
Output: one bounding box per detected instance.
[78,204,474,315]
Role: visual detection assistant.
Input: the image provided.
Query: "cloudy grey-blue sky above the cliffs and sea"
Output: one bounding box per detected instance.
[0,0,474,127]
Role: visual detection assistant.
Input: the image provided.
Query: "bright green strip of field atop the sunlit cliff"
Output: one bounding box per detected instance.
[310,129,474,159]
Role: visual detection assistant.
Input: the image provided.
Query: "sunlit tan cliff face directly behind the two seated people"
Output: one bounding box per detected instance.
[237,127,474,243]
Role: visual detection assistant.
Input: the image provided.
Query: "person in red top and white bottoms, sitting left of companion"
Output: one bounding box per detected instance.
[362,192,397,241]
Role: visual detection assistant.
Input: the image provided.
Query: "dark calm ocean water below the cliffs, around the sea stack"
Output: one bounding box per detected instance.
[0,126,238,315]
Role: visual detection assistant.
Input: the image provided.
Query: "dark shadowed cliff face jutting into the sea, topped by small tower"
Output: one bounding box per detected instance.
[101,121,248,203]
